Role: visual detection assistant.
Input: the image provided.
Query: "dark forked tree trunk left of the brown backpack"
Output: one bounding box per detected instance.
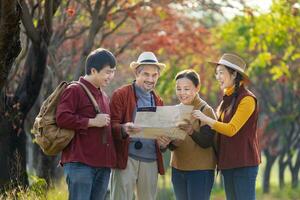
[0,0,60,189]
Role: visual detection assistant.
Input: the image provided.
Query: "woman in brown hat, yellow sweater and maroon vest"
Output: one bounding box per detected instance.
[193,54,261,200]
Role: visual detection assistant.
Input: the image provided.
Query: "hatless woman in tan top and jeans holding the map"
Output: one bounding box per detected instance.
[170,70,216,200]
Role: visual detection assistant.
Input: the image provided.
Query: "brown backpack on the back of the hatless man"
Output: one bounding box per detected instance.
[31,81,100,156]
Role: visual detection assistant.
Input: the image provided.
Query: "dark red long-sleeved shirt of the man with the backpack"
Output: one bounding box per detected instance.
[56,77,116,167]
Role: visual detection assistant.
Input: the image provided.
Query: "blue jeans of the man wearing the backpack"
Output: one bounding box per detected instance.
[64,162,111,200]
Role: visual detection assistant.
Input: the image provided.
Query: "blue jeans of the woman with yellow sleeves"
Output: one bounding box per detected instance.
[222,166,258,200]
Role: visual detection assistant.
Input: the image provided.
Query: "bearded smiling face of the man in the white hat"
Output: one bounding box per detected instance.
[136,65,160,92]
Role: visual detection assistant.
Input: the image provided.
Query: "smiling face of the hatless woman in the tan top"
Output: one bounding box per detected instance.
[176,78,199,105]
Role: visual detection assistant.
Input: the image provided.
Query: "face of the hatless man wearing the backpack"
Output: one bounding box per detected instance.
[92,65,116,88]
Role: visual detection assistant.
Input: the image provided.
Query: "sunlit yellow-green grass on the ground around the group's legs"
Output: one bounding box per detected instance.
[0,158,300,200]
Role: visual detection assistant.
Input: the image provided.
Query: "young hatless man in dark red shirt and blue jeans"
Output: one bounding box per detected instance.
[56,49,116,200]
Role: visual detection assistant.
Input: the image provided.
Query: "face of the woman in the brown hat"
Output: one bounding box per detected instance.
[216,65,237,90]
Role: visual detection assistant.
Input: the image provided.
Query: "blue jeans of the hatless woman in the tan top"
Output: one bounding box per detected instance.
[172,168,214,200]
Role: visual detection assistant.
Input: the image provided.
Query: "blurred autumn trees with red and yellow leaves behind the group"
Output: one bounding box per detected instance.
[0,0,300,198]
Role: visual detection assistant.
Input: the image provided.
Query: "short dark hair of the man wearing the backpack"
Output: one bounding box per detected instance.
[85,48,116,75]
